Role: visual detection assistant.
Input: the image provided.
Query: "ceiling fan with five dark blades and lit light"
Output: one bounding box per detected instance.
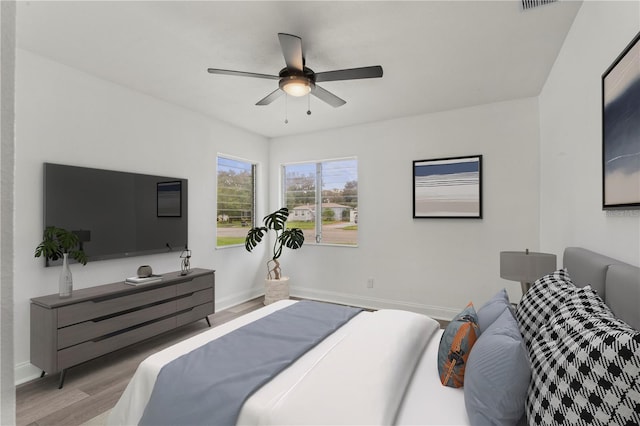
[207,33,382,107]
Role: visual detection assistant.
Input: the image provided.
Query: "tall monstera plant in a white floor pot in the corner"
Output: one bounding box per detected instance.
[244,207,304,305]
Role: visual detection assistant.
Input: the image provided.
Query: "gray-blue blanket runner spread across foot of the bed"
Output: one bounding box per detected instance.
[139,301,361,426]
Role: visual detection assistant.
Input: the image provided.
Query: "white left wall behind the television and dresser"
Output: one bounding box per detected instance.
[14,49,268,381]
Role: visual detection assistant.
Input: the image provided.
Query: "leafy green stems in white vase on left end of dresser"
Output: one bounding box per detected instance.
[35,226,87,297]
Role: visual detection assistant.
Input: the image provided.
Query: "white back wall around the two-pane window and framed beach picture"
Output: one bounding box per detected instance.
[269,98,539,318]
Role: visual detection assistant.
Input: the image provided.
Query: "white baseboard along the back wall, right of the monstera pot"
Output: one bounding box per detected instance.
[290,285,459,321]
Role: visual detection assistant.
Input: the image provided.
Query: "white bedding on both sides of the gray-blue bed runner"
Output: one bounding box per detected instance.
[107,301,468,425]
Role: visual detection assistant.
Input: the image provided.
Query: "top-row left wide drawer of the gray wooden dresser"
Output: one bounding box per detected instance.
[58,285,176,327]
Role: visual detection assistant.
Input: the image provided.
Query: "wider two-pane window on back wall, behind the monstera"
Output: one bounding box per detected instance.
[282,158,358,246]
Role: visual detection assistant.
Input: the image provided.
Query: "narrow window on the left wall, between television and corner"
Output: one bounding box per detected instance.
[216,156,256,247]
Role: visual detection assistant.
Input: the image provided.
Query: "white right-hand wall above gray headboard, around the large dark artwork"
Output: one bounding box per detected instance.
[539,1,640,265]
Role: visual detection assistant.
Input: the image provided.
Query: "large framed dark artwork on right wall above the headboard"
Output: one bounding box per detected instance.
[602,33,640,210]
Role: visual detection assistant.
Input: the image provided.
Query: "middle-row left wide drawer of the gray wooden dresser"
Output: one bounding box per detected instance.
[58,300,176,349]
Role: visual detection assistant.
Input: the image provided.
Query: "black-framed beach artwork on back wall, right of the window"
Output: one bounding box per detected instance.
[413,155,482,219]
